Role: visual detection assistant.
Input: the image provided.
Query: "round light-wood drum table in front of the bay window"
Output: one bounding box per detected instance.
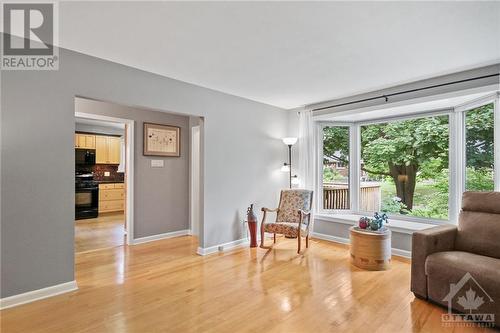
[349,226,391,271]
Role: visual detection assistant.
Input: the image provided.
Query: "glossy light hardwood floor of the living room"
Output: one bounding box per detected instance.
[1,236,494,333]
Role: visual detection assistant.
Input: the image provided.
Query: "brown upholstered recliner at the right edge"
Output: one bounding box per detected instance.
[411,192,500,327]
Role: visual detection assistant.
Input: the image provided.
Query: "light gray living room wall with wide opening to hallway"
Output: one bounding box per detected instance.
[1,45,287,297]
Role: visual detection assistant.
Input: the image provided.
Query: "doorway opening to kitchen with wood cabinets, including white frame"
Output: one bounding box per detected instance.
[74,100,134,253]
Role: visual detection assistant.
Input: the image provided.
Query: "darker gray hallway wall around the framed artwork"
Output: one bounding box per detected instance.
[75,98,189,238]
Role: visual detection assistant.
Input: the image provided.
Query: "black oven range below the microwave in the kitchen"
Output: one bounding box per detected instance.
[75,175,99,220]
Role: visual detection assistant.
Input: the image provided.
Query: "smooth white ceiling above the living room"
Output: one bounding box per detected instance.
[59,1,500,108]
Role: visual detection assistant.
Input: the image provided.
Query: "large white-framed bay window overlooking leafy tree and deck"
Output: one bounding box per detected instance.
[317,93,500,223]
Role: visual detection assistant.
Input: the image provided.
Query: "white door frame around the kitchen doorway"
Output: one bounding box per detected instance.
[75,112,135,245]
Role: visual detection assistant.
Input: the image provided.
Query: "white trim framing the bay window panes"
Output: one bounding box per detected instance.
[315,92,500,225]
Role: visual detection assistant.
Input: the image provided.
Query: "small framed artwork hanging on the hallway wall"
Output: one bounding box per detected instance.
[143,123,181,157]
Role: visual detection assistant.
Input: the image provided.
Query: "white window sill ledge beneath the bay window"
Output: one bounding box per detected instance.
[314,214,436,235]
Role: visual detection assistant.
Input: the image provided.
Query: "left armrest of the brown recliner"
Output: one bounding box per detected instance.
[411,225,457,298]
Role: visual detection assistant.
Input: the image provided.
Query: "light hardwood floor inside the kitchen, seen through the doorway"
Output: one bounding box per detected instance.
[75,212,125,253]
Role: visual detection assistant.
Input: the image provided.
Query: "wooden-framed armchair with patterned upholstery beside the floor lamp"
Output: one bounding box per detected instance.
[260,189,313,253]
